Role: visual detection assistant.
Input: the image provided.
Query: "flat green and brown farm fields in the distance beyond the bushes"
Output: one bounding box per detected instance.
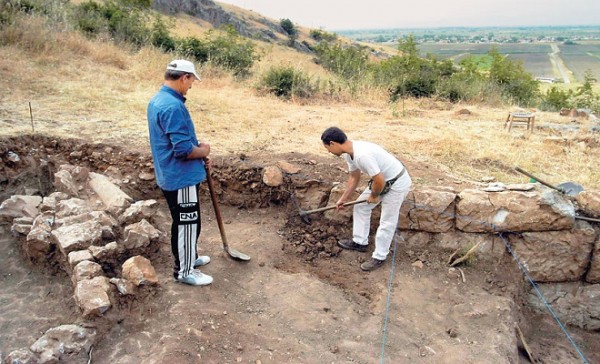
[418,42,600,82]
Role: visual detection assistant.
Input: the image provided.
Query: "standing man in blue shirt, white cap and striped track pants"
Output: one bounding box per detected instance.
[147,60,213,286]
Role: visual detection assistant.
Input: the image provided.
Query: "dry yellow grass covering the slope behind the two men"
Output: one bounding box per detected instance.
[0,15,600,189]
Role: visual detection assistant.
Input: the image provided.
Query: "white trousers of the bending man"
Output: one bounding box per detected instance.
[352,173,412,260]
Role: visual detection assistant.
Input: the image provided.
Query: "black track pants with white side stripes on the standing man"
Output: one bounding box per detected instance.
[162,185,201,278]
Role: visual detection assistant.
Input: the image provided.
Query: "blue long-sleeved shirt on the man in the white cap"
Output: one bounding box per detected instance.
[147,85,206,191]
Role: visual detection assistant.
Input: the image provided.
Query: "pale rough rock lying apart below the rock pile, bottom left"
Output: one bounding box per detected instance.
[30,325,96,364]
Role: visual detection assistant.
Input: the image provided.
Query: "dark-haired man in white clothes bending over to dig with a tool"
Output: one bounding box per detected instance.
[321,127,412,271]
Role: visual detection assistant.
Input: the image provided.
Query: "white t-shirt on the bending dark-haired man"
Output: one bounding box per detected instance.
[343,140,404,181]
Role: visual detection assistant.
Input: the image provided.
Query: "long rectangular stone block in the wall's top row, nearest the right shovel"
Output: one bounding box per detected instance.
[456,189,575,232]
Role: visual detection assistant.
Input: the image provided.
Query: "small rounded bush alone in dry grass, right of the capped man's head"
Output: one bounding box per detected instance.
[257,66,316,98]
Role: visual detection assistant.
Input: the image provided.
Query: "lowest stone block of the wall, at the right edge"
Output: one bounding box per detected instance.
[528,283,600,331]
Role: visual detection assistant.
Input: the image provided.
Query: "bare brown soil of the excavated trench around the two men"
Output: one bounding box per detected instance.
[0,136,600,363]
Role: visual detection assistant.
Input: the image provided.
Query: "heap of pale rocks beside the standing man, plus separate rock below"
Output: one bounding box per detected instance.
[0,165,165,363]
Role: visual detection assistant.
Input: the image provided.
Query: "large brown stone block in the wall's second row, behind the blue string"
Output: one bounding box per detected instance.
[508,221,596,282]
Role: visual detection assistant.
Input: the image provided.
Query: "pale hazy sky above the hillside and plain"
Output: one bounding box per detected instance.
[217,0,600,31]
